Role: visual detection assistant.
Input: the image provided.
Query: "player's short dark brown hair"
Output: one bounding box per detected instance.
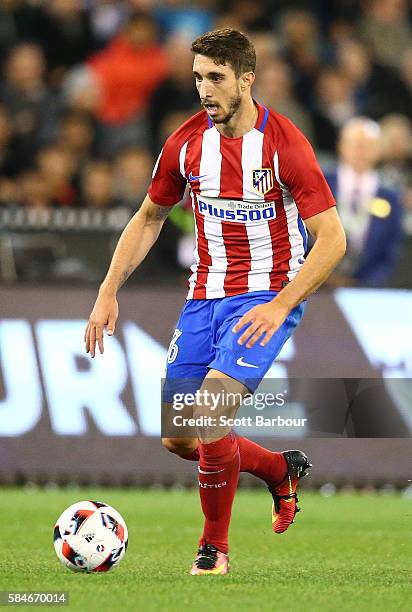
[191,28,256,78]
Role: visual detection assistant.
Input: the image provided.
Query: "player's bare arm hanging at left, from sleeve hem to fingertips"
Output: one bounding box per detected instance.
[84,196,172,357]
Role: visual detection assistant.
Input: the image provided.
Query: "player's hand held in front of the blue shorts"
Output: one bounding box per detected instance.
[232,300,289,348]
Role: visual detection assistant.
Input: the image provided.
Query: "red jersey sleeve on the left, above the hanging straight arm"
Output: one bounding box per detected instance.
[147,135,186,206]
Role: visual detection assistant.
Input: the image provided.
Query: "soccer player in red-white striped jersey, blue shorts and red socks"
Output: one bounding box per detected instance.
[85,28,345,575]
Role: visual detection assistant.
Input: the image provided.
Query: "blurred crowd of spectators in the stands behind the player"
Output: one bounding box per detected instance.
[0,0,412,284]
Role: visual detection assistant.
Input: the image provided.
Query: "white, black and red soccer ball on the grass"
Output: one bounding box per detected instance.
[54,501,128,572]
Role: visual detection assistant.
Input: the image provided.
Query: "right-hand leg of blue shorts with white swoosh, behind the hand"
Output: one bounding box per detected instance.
[209,291,305,392]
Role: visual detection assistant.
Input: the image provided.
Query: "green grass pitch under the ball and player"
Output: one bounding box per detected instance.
[0,488,412,612]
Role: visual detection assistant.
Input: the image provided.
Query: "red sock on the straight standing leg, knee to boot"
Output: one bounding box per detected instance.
[198,433,240,553]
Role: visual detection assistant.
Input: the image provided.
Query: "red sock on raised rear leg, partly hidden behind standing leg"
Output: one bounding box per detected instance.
[182,436,287,484]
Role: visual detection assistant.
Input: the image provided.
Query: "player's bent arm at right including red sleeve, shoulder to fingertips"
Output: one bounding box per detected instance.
[233,123,346,348]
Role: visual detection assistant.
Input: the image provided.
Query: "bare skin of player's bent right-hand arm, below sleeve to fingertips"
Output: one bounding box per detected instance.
[233,208,346,348]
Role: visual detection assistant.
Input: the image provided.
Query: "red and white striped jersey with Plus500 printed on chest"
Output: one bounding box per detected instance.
[148,104,335,299]
